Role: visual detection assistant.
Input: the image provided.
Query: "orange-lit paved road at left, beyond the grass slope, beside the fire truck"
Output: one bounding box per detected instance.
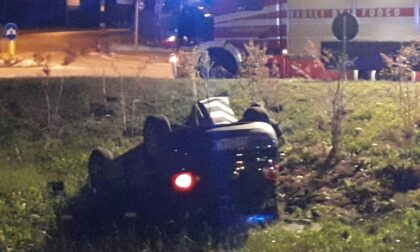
[0,30,173,78]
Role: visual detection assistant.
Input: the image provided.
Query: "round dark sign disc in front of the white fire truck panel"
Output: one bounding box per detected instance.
[332,12,359,41]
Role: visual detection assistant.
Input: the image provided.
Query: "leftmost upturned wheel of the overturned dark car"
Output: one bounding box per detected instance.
[88,147,113,190]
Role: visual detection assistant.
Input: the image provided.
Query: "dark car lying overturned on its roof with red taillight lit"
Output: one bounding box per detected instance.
[83,97,281,227]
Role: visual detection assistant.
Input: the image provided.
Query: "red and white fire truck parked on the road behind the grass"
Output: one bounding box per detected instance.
[140,0,420,79]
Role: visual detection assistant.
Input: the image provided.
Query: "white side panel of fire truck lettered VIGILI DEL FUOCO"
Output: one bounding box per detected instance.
[287,0,420,54]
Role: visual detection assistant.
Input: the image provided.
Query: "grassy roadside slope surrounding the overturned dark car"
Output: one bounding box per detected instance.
[0,78,420,251]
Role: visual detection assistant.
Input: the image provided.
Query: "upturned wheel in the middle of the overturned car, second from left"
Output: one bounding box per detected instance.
[143,115,171,158]
